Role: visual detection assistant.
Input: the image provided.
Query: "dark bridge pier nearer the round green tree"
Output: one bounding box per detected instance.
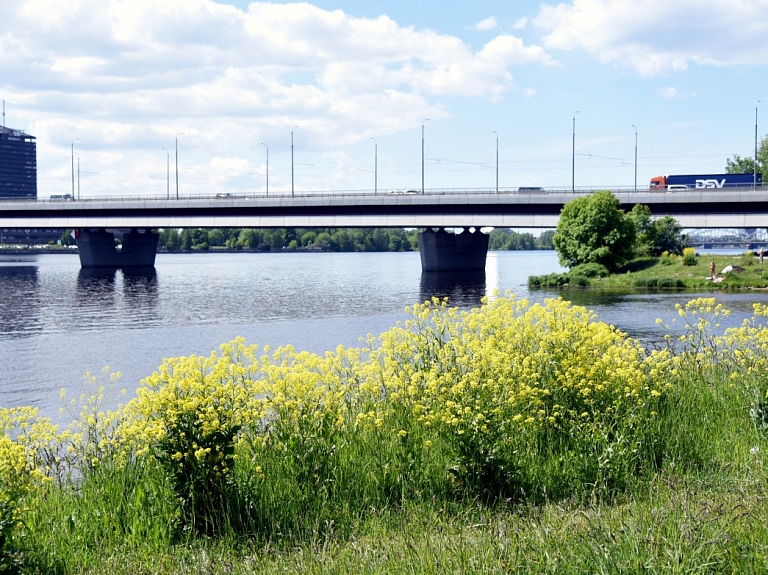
[419,228,490,272]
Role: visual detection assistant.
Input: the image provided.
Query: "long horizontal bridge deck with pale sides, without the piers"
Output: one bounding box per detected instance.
[0,188,768,229]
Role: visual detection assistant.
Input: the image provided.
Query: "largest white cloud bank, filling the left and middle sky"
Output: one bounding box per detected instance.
[0,0,554,196]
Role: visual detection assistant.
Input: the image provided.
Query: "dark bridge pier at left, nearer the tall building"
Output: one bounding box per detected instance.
[75,228,159,268]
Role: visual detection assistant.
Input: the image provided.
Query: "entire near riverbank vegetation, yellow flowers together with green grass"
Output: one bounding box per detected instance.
[0,296,768,573]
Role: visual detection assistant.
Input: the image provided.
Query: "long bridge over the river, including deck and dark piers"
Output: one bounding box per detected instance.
[0,187,768,271]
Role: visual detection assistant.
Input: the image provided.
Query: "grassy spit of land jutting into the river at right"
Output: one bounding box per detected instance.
[528,248,768,291]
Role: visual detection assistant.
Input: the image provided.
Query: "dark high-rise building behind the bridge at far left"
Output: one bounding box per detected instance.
[0,126,37,200]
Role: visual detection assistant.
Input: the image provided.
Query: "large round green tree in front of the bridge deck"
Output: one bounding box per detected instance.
[552,190,636,271]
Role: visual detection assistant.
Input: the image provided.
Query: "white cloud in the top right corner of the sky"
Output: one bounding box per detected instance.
[534,0,768,76]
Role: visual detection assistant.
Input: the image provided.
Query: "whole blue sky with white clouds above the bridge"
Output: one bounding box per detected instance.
[0,0,768,198]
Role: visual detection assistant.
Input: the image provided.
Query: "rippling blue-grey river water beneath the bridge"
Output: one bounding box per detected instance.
[0,251,768,415]
